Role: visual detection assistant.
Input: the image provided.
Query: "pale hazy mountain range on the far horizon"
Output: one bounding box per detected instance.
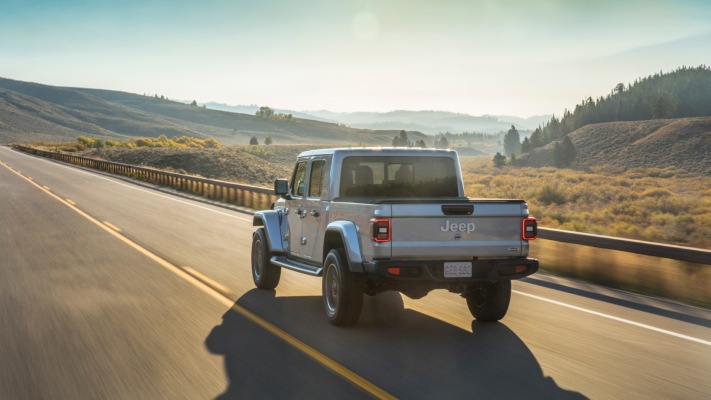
[304,110,551,135]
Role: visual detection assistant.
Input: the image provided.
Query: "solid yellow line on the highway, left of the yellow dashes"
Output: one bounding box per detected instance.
[3,160,396,399]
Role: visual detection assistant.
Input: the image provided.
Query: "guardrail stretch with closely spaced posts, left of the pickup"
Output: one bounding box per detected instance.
[12,145,277,209]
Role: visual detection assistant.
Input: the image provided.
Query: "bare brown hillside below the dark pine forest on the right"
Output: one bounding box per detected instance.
[517,117,711,175]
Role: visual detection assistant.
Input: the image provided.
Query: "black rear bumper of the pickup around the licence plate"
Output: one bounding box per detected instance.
[363,258,538,287]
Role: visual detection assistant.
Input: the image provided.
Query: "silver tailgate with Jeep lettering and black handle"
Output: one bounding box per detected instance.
[391,200,528,260]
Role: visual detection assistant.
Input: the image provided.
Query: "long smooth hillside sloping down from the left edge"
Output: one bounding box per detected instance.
[0,78,425,146]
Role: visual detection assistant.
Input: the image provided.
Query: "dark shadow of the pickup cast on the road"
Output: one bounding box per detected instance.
[205,289,585,399]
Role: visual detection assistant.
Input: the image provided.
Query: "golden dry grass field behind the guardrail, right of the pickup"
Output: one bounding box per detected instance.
[462,157,711,248]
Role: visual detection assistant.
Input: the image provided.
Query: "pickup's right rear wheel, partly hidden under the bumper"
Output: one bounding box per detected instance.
[466,280,511,321]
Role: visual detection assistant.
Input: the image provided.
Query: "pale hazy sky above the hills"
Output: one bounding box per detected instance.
[0,0,711,117]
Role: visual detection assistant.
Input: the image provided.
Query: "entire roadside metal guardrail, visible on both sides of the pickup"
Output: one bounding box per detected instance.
[12,145,711,264]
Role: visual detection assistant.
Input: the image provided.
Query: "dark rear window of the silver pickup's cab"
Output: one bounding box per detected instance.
[340,156,459,198]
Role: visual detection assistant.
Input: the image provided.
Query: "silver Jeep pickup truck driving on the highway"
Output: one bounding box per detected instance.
[252,148,538,326]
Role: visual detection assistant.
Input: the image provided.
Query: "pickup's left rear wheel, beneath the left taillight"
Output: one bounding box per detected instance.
[322,249,365,326]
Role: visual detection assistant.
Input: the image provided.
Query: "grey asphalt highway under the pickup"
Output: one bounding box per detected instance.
[0,147,711,399]
